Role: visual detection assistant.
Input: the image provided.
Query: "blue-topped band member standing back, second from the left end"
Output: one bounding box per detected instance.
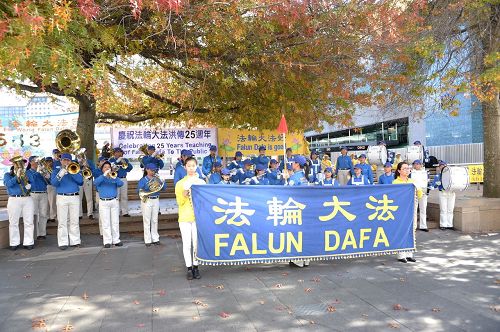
[26,156,50,240]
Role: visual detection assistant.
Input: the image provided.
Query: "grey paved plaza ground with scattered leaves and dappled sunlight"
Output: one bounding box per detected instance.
[0,230,500,332]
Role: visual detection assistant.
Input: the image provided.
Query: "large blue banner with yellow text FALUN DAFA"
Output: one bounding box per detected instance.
[192,184,415,265]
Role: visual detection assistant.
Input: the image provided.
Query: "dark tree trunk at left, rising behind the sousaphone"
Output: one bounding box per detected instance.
[76,95,96,160]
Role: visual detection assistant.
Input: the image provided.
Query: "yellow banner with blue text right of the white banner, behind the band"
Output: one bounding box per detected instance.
[217,128,309,157]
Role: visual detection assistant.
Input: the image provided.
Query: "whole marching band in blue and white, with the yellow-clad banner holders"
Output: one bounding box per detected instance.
[4,130,468,272]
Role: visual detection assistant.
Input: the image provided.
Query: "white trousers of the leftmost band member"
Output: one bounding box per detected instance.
[7,196,35,246]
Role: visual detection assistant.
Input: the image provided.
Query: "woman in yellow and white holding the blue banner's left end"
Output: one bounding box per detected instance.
[175,157,205,280]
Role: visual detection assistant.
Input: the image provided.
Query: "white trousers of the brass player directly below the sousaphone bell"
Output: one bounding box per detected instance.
[57,195,81,247]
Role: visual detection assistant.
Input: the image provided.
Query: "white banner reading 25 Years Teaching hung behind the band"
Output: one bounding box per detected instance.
[112,127,217,160]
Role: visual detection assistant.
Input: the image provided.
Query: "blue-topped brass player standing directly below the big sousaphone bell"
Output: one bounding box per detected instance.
[50,153,83,250]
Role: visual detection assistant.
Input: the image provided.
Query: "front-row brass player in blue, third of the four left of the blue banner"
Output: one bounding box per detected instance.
[94,161,123,248]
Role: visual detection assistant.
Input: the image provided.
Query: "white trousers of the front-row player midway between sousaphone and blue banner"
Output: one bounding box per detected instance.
[99,199,120,244]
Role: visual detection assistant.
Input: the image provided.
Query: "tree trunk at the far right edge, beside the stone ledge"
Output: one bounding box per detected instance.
[482,92,500,198]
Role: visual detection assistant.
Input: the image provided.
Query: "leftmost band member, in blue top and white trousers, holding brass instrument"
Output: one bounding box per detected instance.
[3,160,35,250]
